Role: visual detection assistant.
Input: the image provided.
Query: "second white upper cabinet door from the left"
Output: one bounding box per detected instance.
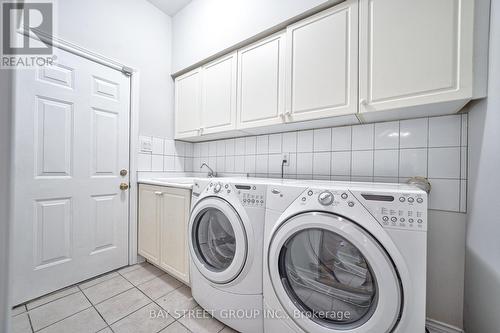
[201,52,238,134]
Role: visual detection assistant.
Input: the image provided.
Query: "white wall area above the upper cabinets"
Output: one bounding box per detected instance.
[172,0,333,72]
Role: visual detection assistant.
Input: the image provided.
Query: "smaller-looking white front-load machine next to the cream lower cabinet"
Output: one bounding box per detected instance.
[189,178,267,333]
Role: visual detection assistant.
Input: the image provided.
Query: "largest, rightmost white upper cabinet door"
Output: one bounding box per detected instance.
[360,0,474,116]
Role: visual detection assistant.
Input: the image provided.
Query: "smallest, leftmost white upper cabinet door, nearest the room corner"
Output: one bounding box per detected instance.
[175,68,201,139]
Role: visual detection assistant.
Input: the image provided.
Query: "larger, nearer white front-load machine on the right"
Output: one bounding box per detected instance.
[263,181,427,333]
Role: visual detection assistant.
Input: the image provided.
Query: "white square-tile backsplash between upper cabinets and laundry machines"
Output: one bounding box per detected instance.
[138,114,468,212]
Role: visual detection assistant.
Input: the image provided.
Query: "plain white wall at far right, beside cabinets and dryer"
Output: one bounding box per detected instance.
[464,1,500,333]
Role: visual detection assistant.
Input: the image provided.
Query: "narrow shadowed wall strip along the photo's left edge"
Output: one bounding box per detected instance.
[0,69,12,332]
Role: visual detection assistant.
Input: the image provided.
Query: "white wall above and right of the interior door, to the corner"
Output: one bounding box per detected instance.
[51,0,174,137]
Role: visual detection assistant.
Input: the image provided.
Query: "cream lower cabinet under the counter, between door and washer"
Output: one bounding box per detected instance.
[138,184,191,284]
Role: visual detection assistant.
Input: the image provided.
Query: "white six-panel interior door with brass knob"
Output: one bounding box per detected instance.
[12,49,130,304]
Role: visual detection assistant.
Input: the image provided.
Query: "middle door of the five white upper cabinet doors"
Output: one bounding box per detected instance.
[238,33,285,129]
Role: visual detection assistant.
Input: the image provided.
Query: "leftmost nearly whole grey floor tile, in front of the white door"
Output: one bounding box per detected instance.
[29,292,91,331]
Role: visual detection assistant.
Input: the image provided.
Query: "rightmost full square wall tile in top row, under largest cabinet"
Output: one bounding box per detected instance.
[429,115,462,147]
